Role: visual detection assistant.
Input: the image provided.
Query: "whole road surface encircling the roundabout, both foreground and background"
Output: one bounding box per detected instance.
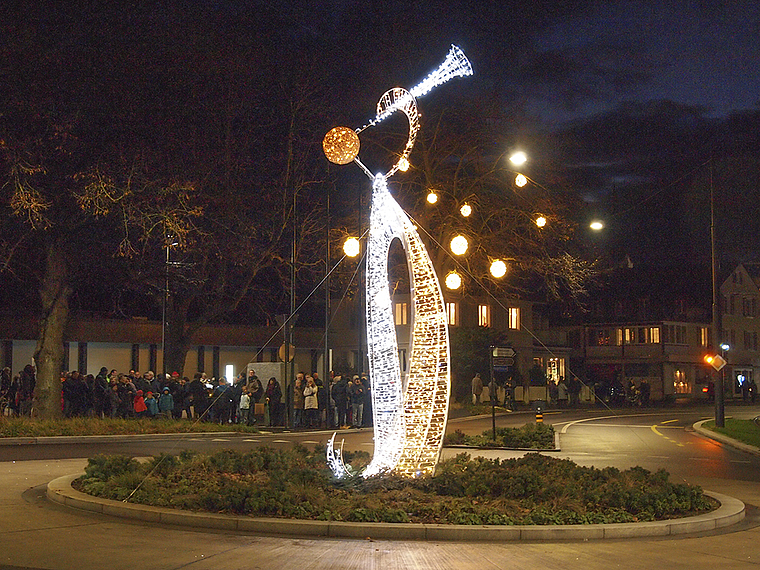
[0,400,760,570]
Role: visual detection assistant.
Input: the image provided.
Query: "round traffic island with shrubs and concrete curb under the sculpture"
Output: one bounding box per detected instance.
[47,447,744,541]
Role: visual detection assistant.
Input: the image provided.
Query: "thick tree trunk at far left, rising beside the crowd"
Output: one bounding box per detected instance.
[34,241,72,419]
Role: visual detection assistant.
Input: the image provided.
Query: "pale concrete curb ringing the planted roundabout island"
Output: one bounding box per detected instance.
[47,474,745,542]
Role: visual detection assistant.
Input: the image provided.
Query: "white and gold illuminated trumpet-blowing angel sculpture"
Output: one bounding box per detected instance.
[323,46,472,477]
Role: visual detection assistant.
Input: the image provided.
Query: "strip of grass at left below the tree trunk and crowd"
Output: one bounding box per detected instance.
[0,416,258,437]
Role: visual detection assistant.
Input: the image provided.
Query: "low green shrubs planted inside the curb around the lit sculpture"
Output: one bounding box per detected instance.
[74,446,714,525]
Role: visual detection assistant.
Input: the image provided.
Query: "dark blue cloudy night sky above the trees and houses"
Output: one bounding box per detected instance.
[5,0,760,276]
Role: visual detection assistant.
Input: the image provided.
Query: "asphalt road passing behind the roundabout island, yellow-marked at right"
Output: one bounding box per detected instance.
[0,406,760,482]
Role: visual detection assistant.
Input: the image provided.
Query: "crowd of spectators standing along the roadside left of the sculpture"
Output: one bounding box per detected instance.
[0,365,372,429]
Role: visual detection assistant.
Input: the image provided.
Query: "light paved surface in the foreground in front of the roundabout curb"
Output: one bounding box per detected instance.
[0,452,760,570]
